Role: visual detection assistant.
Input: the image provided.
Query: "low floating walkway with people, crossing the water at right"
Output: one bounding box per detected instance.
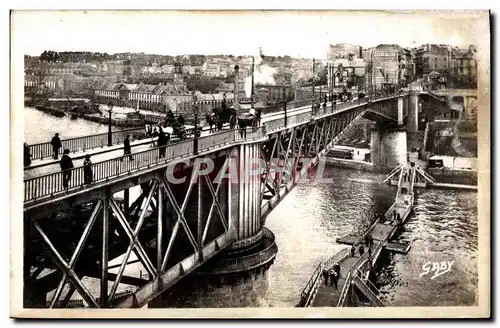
[298,166,418,307]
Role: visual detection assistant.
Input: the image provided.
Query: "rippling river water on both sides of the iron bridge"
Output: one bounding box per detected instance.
[24,108,478,307]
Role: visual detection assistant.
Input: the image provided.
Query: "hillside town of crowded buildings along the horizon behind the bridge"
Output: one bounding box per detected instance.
[24,43,477,119]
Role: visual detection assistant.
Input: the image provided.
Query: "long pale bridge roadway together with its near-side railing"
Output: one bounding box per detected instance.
[24,93,402,206]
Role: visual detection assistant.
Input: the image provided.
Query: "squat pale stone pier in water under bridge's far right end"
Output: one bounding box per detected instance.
[370,127,407,168]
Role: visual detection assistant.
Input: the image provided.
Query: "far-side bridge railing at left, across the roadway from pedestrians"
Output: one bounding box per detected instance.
[29,128,146,159]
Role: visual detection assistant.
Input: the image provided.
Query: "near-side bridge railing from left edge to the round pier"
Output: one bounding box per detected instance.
[24,126,266,202]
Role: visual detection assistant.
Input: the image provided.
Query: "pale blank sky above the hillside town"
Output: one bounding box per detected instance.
[12,11,484,58]
